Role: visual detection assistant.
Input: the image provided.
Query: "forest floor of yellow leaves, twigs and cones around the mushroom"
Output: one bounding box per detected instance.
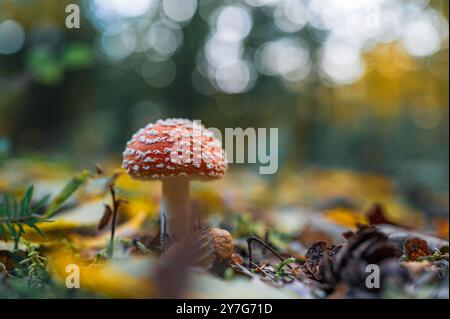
[0,159,449,298]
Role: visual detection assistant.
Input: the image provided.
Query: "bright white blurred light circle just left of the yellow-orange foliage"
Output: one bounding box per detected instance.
[320,40,364,85]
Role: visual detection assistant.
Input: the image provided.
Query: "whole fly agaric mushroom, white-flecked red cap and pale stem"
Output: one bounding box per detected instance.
[122,119,228,248]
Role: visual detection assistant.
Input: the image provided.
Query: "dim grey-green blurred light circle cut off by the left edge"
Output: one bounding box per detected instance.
[0,20,25,54]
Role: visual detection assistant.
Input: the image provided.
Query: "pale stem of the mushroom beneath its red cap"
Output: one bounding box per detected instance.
[161,179,192,249]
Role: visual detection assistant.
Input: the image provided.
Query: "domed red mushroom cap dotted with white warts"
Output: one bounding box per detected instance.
[122,119,228,179]
